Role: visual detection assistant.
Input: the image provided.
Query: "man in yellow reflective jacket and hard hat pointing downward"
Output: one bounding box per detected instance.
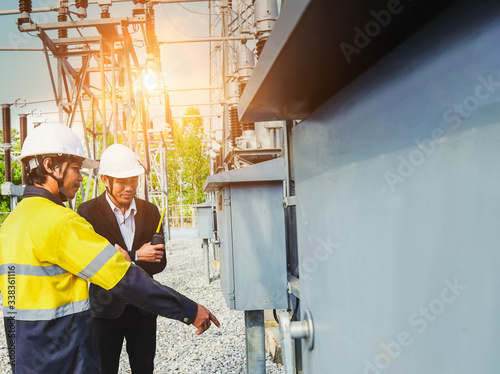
[0,124,219,374]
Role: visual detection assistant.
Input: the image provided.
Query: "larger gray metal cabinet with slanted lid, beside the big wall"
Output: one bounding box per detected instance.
[205,159,288,311]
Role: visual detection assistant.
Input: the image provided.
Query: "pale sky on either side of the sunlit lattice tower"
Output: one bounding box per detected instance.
[0,0,219,131]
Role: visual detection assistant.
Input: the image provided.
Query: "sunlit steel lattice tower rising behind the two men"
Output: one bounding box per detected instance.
[18,0,173,216]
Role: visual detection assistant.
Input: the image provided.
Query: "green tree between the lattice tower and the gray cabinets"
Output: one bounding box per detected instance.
[167,107,210,205]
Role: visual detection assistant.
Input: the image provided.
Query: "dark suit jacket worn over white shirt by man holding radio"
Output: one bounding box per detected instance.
[77,192,167,319]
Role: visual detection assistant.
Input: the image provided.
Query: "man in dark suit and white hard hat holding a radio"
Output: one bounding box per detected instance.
[77,144,166,374]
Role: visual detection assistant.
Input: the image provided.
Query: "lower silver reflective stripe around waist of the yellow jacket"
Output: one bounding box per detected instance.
[3,299,90,321]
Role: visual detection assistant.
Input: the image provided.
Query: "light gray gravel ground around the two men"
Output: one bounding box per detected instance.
[0,239,284,374]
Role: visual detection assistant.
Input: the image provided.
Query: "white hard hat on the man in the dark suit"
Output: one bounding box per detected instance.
[99,144,144,178]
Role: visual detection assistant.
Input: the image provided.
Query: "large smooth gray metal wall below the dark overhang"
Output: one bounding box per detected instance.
[293,1,500,374]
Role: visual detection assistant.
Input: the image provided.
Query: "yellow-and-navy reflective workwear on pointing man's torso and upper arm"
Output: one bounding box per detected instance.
[0,191,130,374]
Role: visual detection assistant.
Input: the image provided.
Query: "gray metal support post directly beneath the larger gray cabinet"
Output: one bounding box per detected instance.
[245,310,266,374]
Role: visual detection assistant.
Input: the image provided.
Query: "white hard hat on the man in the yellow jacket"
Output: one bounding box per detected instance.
[19,123,99,169]
